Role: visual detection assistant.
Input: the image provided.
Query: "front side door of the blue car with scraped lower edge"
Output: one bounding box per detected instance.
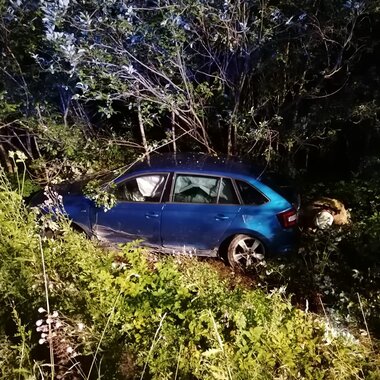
[93,173,168,246]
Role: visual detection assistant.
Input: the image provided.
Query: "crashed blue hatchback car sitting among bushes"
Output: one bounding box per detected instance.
[36,154,297,269]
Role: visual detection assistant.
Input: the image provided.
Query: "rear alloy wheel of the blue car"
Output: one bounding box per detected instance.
[227,234,265,270]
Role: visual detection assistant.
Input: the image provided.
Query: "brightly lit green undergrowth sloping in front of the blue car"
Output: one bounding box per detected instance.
[0,164,380,380]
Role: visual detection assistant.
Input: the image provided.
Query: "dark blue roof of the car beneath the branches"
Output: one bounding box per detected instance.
[125,153,261,178]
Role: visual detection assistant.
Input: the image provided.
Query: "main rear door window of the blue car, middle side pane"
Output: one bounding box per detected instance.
[172,174,219,203]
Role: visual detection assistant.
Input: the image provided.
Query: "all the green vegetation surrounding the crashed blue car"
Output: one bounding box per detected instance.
[0,0,380,379]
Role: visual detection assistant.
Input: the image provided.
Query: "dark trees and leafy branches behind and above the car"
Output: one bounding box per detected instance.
[0,0,379,177]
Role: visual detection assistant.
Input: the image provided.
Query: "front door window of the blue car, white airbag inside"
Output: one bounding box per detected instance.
[115,174,166,202]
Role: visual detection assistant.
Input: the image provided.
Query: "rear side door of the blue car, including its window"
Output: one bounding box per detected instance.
[161,174,240,254]
